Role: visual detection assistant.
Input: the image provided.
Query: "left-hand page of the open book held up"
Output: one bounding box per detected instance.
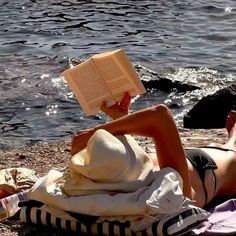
[63,59,114,115]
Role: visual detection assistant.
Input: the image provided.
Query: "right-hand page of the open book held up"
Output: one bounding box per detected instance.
[92,50,145,101]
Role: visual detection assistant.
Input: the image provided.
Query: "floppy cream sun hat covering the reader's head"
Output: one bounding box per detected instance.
[64,129,153,195]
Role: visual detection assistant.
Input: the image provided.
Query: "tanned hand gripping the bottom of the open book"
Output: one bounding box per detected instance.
[101,92,131,120]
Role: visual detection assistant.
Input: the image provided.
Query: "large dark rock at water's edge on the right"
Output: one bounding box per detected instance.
[183,83,236,129]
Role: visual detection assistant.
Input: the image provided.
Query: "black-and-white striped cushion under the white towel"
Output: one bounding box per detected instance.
[20,205,209,236]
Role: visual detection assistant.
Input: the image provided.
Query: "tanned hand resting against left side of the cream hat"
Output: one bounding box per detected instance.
[70,129,94,155]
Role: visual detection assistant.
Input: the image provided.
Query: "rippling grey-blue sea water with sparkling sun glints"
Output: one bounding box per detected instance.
[0,0,236,149]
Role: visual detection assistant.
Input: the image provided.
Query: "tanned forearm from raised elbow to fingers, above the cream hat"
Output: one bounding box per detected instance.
[72,105,175,148]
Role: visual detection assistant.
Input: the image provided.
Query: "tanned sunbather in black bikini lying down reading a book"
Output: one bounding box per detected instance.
[71,94,236,207]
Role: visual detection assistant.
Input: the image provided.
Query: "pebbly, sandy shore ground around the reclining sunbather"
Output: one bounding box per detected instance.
[0,129,227,236]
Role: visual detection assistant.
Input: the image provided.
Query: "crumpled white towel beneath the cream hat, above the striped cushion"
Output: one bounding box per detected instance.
[29,168,185,216]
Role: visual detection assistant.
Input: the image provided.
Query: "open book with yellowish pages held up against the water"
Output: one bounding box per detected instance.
[63,49,146,115]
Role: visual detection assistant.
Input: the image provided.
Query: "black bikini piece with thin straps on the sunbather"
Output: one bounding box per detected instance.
[185,148,218,205]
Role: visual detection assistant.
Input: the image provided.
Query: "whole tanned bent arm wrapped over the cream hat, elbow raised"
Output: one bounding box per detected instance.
[72,105,192,199]
